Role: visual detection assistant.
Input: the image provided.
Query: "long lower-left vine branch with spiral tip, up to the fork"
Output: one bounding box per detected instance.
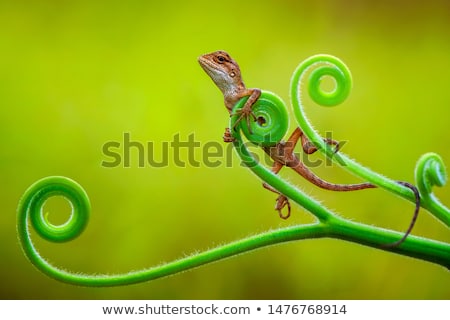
[17,177,329,287]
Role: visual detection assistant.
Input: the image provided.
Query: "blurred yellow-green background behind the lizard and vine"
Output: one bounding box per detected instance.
[0,0,450,299]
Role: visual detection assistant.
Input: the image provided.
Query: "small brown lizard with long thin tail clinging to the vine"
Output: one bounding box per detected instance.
[198,51,420,246]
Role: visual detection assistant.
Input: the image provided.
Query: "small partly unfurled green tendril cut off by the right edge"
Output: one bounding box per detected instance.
[415,153,450,226]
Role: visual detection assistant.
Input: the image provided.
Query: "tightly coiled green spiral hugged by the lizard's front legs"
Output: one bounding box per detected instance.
[236,91,289,147]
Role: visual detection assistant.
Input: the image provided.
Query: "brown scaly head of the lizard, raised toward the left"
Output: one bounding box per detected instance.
[198,51,242,92]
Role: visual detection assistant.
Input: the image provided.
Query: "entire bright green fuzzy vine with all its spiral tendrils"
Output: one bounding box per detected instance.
[17,55,450,286]
